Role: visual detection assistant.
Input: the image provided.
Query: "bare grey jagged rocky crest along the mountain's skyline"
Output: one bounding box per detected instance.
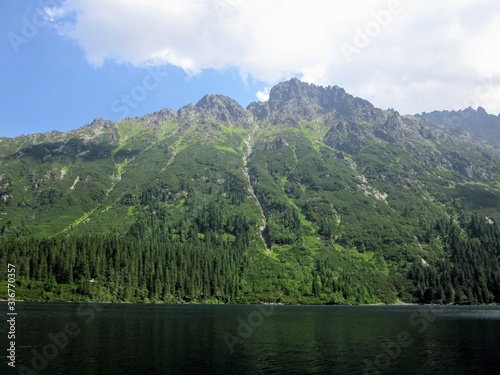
[0,78,500,144]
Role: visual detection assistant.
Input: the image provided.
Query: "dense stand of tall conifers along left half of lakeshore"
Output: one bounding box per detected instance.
[0,235,246,302]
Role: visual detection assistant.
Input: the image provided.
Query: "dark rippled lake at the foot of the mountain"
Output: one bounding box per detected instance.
[0,302,500,375]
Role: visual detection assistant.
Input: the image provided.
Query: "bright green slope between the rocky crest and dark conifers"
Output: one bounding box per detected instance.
[0,117,500,303]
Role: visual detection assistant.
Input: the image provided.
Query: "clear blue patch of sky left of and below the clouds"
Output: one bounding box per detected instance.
[0,0,265,137]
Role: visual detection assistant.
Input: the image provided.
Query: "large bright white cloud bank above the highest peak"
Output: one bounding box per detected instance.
[53,0,500,113]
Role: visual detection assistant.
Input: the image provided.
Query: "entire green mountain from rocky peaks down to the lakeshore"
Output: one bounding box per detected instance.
[0,79,500,303]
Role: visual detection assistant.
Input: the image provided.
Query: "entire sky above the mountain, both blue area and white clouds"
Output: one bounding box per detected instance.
[0,0,500,137]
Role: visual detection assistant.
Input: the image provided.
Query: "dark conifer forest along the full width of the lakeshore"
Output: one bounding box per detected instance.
[0,216,500,304]
